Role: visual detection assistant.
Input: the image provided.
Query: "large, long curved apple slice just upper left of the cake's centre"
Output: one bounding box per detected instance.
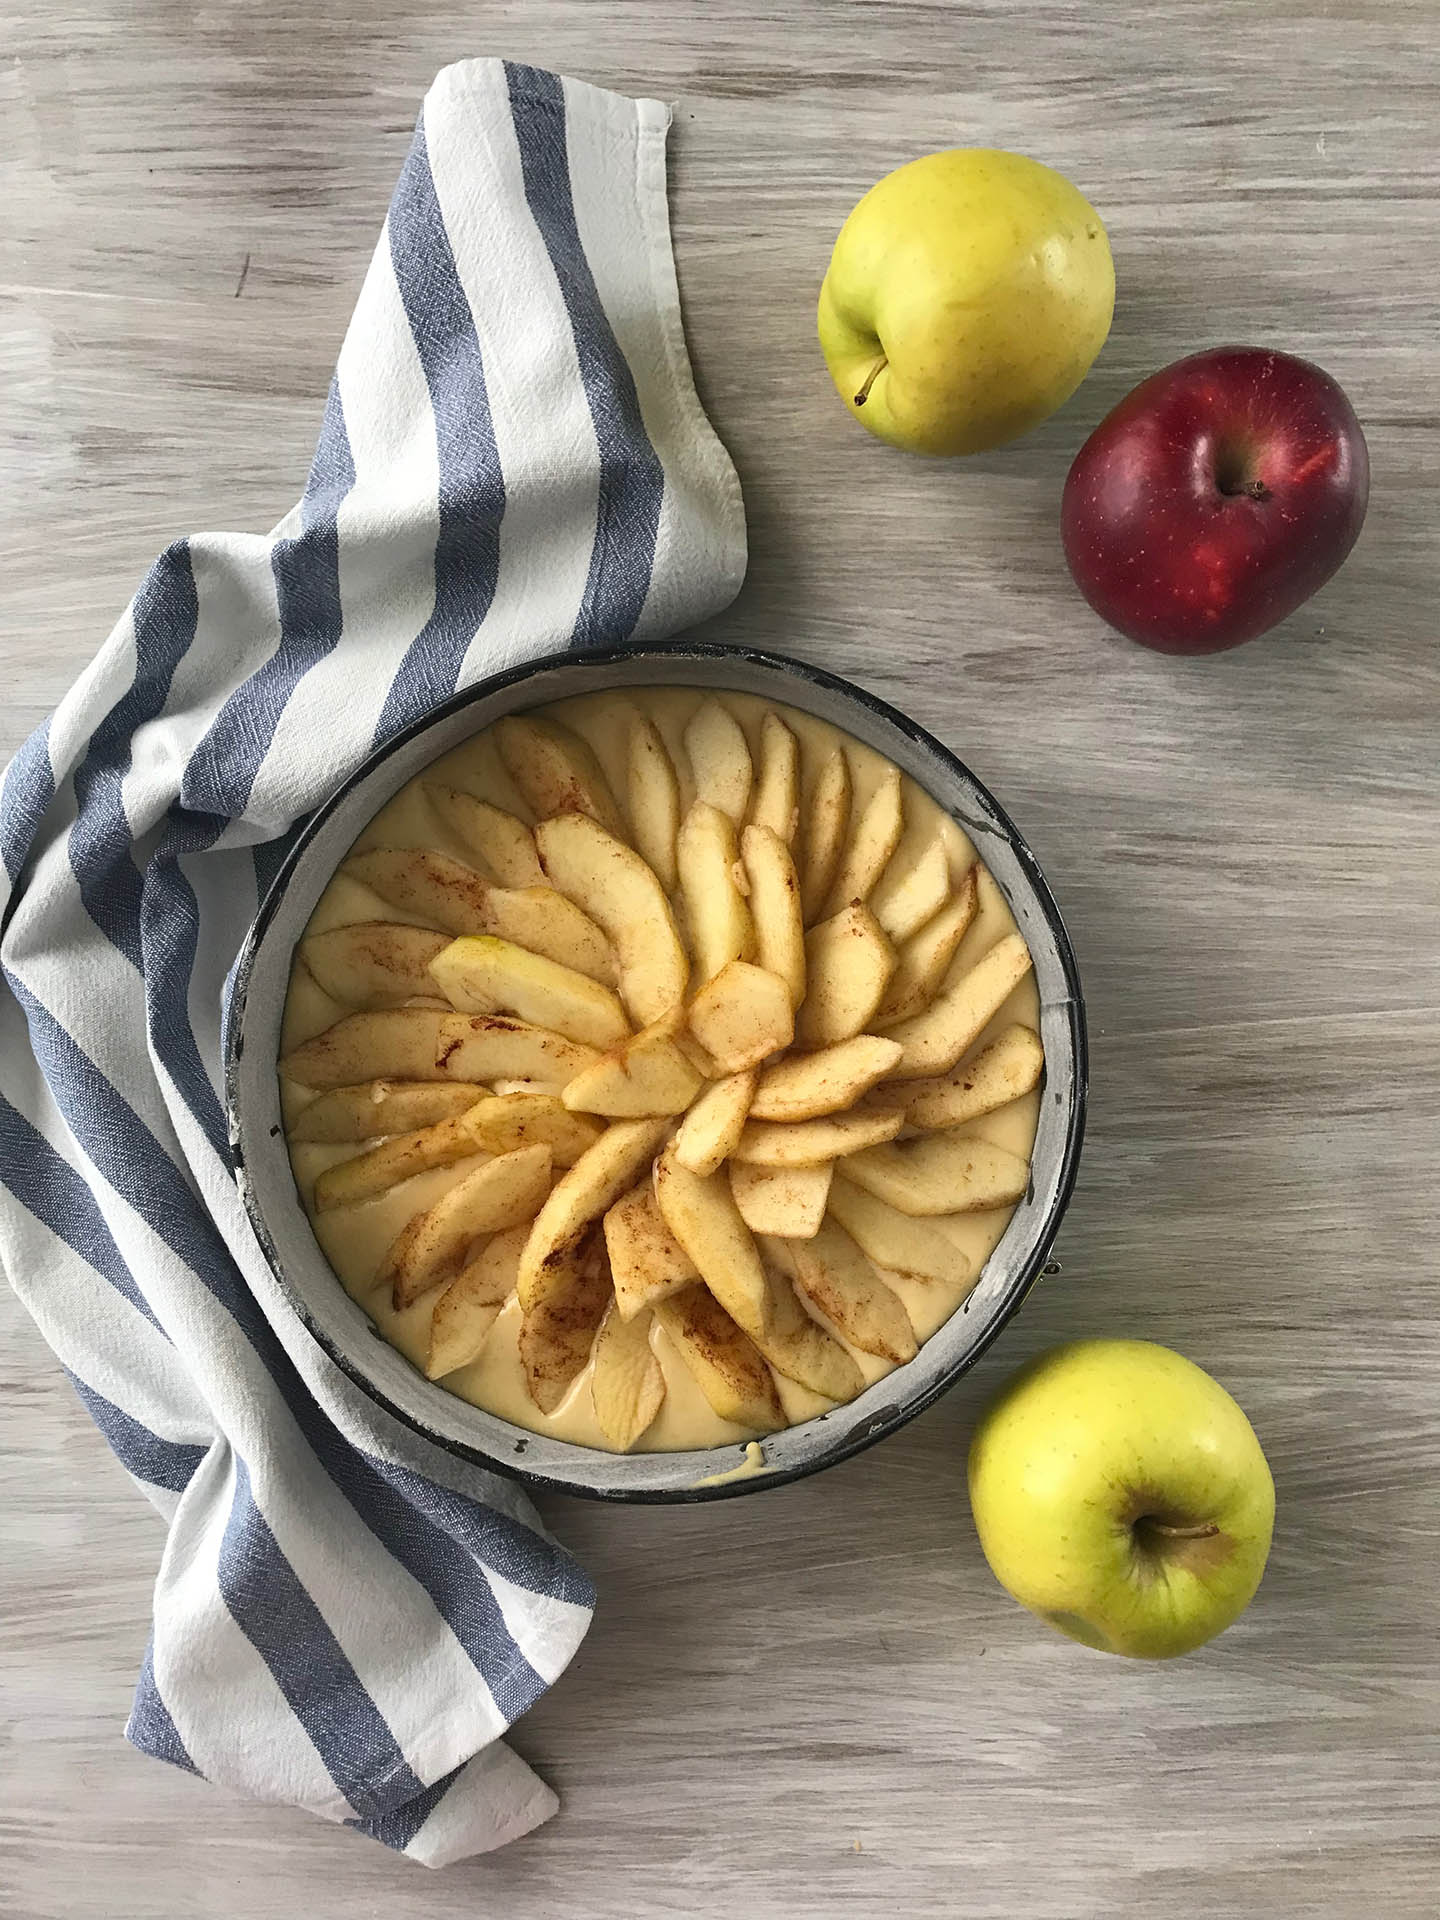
[536,814,689,1027]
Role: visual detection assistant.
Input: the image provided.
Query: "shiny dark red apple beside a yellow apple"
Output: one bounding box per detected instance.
[1060,348,1371,653]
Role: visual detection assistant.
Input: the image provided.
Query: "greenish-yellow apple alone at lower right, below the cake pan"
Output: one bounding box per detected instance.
[970,1340,1275,1661]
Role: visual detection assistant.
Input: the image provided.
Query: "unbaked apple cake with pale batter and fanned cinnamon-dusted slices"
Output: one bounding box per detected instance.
[280,687,1043,1452]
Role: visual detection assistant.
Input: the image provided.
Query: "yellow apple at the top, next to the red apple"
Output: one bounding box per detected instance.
[820,148,1116,455]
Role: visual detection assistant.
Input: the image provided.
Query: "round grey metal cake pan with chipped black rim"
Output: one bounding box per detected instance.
[225,641,1087,1501]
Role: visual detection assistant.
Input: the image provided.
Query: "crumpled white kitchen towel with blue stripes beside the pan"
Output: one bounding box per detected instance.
[0,60,745,1866]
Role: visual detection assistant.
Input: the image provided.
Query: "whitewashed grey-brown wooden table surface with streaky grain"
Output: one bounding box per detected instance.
[0,0,1440,1920]
